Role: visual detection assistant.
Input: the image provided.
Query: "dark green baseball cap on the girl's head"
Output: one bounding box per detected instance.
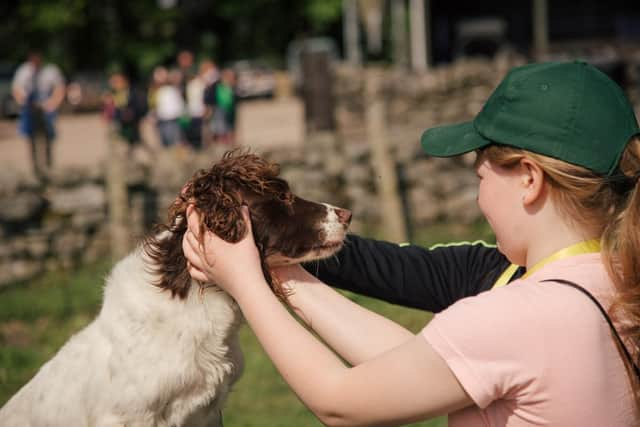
[421,61,640,175]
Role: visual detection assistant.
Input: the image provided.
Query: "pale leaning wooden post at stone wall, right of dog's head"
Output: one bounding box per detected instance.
[365,69,407,243]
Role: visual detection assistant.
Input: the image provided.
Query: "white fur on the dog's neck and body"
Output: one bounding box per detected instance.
[0,249,242,427]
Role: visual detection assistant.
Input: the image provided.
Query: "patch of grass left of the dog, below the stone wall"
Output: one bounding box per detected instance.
[0,263,109,404]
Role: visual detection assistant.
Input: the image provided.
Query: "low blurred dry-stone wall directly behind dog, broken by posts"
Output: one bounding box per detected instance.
[0,139,478,286]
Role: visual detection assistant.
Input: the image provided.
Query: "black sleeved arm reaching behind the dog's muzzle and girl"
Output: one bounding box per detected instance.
[304,235,510,312]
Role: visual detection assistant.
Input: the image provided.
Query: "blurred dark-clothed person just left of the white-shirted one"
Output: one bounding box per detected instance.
[107,71,147,147]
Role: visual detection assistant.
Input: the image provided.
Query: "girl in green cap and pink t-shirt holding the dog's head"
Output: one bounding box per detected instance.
[183,62,640,426]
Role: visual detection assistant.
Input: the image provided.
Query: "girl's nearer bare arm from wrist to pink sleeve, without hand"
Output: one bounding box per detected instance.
[234,280,472,426]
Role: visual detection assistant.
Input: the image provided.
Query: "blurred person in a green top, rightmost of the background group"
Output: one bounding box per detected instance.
[204,68,237,144]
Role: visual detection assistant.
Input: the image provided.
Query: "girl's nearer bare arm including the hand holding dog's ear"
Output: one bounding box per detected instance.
[183,208,472,426]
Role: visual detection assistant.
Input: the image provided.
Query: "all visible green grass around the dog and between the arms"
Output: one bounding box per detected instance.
[0,224,493,427]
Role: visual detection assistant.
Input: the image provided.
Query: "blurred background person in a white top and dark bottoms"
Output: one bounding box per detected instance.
[155,69,185,147]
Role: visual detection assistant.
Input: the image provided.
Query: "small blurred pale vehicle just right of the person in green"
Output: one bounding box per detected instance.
[229,60,276,100]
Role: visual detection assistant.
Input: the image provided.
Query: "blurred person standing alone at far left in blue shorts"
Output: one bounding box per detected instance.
[11,50,65,177]
